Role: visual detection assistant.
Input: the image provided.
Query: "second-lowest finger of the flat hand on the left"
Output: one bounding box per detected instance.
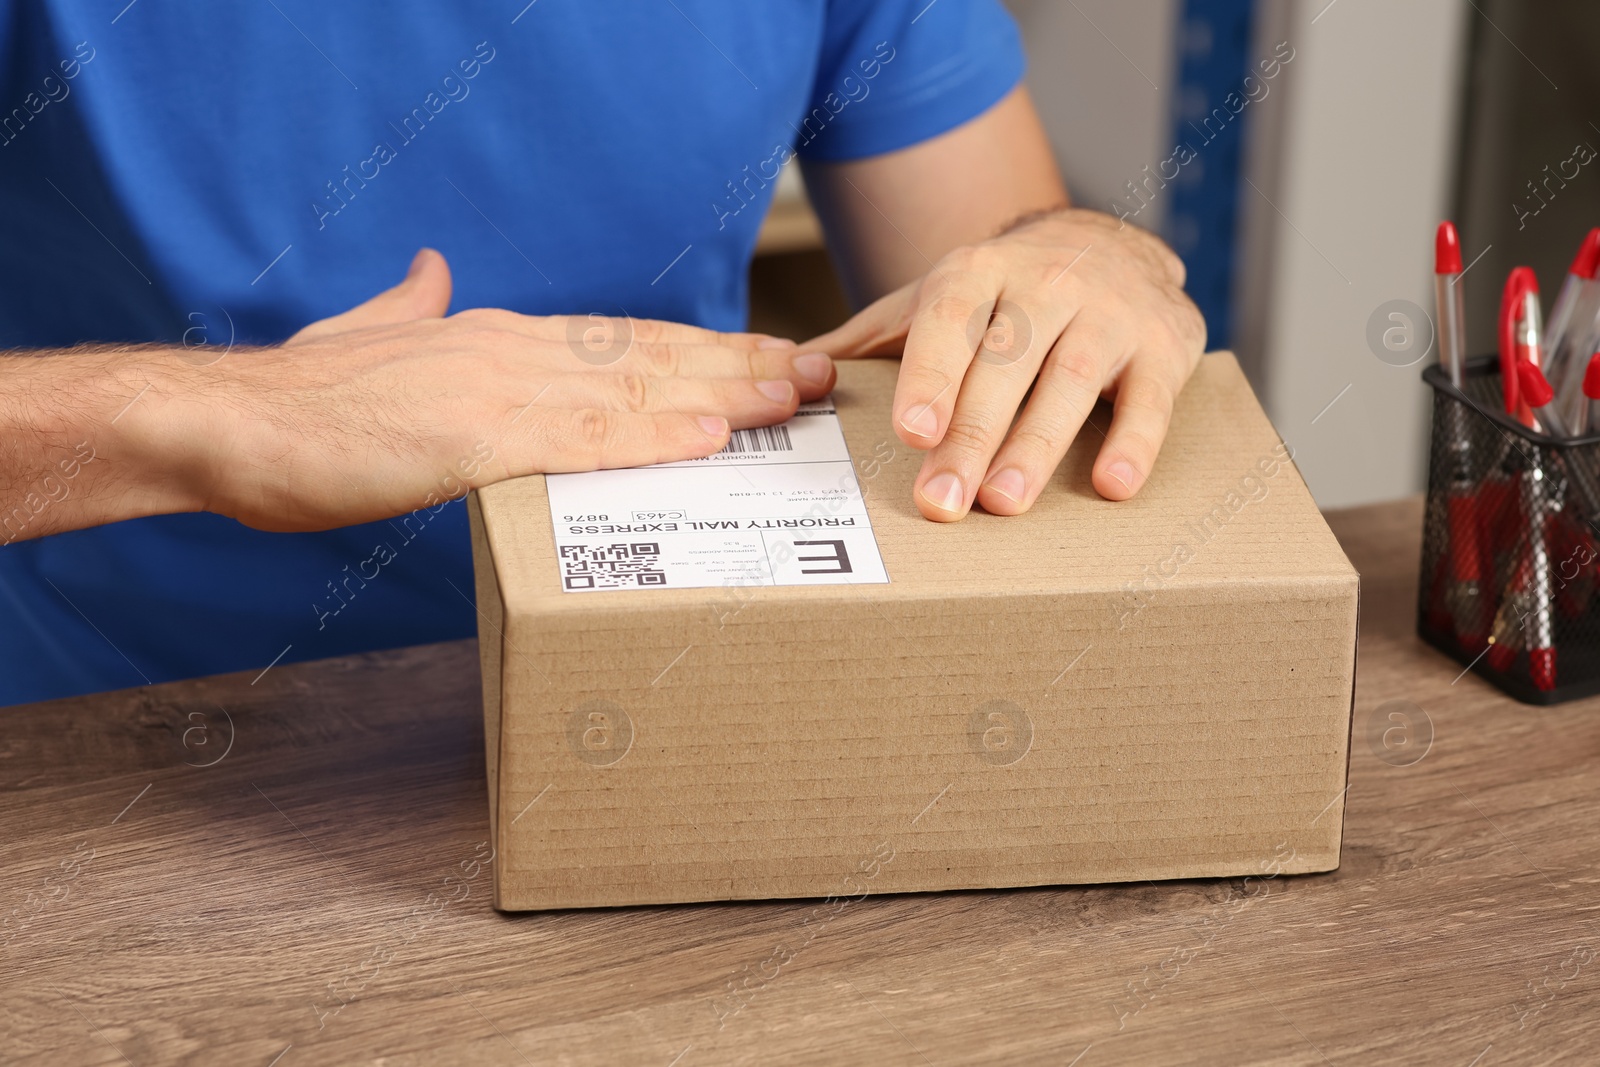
[536,374,800,429]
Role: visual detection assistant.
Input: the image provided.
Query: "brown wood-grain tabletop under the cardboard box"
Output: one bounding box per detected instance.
[0,501,1600,1067]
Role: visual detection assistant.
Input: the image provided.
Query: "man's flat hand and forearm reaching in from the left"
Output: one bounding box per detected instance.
[0,250,835,541]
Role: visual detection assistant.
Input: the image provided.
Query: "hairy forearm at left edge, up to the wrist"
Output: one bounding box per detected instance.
[0,346,198,545]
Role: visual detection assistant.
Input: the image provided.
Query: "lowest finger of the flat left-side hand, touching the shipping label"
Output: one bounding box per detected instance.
[504,406,730,477]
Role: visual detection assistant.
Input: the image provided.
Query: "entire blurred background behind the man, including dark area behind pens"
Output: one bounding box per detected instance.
[755,0,1600,507]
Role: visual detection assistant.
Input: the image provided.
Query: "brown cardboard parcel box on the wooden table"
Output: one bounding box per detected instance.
[470,354,1357,910]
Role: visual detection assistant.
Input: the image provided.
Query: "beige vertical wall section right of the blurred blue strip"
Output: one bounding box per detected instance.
[1242,0,1465,507]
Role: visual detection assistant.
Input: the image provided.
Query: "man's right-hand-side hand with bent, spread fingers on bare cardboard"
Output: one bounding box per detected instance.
[802,210,1205,522]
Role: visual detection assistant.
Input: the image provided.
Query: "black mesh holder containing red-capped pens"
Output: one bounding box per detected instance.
[1416,357,1600,704]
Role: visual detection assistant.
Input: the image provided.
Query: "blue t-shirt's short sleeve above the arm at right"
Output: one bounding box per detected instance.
[795,0,1024,160]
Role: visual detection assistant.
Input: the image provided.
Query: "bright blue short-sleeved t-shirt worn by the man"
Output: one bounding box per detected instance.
[0,0,1022,704]
